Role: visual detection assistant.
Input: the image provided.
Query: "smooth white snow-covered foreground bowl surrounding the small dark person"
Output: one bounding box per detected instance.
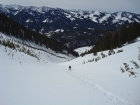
[0,32,140,105]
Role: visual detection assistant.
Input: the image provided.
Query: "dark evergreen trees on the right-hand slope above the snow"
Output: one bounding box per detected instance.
[82,22,140,56]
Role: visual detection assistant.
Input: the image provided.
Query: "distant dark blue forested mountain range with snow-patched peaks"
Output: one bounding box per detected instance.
[0,4,140,49]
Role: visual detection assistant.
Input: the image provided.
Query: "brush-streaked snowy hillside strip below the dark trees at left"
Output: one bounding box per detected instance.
[0,32,74,63]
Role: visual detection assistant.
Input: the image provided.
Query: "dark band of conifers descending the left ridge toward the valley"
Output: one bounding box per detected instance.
[0,14,78,56]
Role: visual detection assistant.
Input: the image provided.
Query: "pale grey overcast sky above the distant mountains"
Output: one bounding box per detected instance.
[0,0,140,14]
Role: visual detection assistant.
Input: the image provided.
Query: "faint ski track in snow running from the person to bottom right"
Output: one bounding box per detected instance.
[70,72,138,105]
